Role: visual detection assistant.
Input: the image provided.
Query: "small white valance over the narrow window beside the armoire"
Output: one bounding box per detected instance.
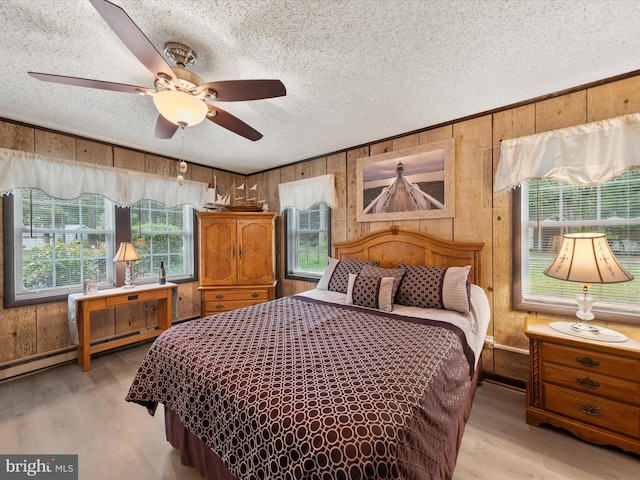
[278,173,338,212]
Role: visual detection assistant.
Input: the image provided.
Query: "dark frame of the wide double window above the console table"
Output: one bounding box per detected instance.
[2,194,199,309]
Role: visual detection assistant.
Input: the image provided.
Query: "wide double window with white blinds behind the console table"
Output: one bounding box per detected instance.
[4,189,195,307]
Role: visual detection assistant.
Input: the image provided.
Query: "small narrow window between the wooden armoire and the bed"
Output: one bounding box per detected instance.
[285,203,331,280]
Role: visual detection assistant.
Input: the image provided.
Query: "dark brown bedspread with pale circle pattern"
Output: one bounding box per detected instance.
[126,297,475,480]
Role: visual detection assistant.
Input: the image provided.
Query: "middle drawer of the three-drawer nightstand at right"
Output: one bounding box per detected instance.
[542,362,640,405]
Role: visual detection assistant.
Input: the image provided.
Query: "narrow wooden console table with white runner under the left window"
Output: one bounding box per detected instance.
[68,283,177,372]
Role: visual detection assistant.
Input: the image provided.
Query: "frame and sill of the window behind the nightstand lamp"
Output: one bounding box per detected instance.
[511,181,640,325]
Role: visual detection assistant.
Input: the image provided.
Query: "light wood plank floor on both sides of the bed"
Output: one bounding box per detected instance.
[0,344,640,480]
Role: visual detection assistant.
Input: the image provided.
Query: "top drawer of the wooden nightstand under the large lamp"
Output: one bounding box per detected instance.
[540,343,640,382]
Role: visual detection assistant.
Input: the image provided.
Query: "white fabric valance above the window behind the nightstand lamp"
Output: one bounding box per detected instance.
[494,113,640,192]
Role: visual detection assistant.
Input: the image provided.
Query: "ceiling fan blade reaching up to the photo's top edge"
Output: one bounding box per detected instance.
[89,0,177,80]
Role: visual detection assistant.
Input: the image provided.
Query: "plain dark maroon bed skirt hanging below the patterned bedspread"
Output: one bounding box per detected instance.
[164,357,482,480]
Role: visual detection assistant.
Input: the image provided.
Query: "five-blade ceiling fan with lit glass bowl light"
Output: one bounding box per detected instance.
[28,0,287,141]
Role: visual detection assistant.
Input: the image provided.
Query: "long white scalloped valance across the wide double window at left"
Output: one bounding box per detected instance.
[0,148,207,209]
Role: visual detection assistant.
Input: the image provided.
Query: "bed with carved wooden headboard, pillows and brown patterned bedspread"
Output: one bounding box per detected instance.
[126,226,490,480]
